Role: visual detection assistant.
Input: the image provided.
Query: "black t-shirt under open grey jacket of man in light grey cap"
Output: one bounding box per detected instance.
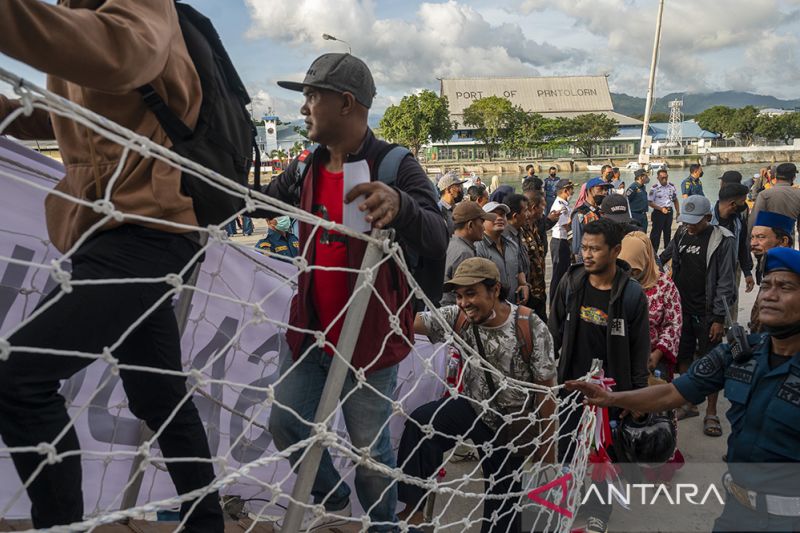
[675,226,713,316]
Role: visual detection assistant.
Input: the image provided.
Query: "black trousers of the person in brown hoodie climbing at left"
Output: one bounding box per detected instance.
[0,225,223,532]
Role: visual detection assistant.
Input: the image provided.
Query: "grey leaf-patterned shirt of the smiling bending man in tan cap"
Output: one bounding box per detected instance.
[419,304,556,429]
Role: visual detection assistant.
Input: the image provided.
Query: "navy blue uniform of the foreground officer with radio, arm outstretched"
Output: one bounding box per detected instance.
[672,334,800,531]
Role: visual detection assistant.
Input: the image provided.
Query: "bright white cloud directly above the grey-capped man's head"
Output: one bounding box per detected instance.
[245,0,586,94]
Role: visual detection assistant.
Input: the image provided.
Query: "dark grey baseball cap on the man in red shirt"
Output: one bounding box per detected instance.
[278,54,377,109]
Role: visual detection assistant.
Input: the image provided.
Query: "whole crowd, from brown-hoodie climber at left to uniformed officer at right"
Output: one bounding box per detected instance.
[0,0,800,533]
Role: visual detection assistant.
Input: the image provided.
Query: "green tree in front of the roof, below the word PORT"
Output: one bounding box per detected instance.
[464,96,522,160]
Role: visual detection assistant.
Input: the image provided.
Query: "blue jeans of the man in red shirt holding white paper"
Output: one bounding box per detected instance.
[269,348,397,531]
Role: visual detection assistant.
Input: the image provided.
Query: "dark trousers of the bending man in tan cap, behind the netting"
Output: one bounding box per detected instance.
[397,398,522,533]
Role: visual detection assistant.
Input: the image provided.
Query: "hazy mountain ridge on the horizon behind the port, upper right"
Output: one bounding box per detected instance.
[611,91,800,116]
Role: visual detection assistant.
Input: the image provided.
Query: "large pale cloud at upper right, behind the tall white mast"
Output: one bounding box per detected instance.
[516,0,800,97]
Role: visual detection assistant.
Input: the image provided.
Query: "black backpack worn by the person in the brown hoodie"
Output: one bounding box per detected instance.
[138,1,261,226]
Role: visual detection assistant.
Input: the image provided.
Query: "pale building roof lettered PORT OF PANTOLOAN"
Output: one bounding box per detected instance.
[441,76,614,116]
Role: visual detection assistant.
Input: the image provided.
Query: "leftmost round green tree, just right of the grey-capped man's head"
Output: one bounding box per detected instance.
[379,89,453,156]
